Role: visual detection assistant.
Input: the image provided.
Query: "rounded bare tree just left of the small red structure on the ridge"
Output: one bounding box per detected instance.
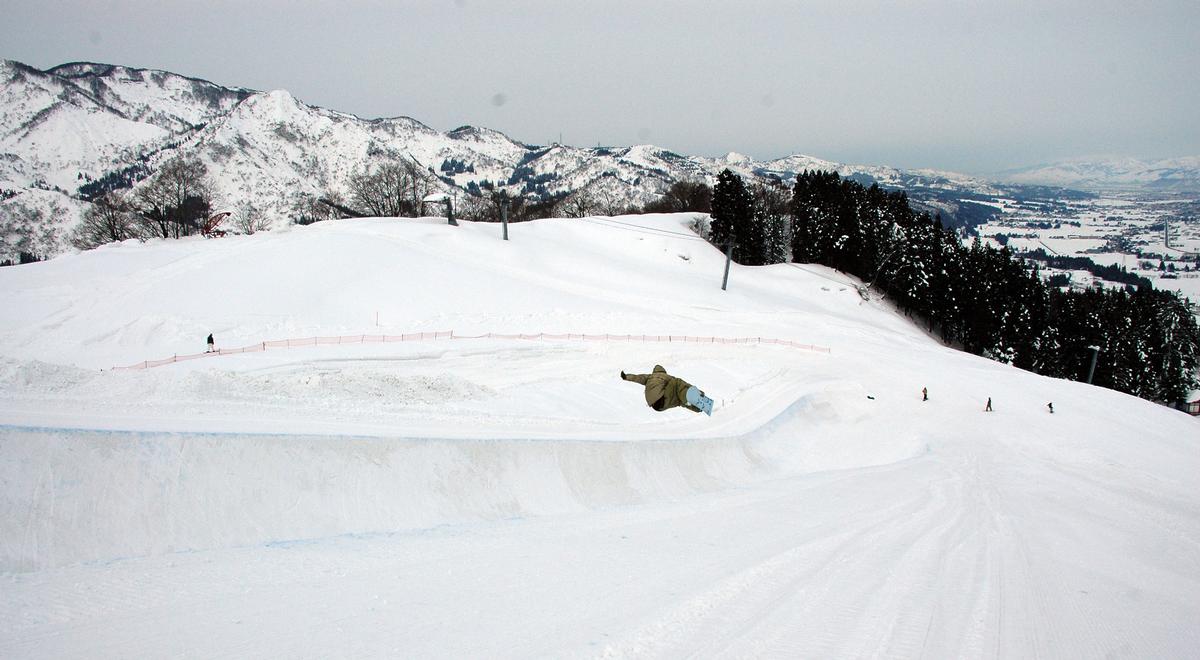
[134,157,216,239]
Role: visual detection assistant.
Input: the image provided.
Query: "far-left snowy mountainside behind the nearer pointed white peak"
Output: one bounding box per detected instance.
[0,60,250,260]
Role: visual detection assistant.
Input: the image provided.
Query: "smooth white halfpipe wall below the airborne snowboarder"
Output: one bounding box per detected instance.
[0,430,787,571]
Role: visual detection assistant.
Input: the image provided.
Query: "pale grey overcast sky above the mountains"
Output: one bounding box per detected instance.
[0,0,1200,173]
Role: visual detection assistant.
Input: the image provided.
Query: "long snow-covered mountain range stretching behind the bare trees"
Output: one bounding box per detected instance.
[0,60,1142,264]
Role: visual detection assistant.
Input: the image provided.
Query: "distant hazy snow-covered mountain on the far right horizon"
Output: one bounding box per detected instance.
[1000,156,1200,192]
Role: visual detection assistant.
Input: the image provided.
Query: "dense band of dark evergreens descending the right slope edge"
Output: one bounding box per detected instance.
[792,172,1200,403]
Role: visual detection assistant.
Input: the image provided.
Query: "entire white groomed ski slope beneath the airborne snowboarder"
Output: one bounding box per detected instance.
[0,215,1200,658]
